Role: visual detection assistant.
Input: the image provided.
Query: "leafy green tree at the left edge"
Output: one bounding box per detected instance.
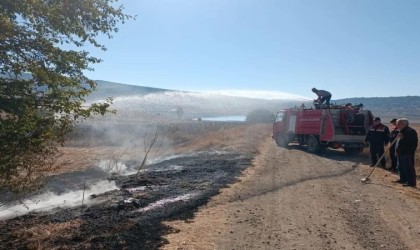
[0,0,133,195]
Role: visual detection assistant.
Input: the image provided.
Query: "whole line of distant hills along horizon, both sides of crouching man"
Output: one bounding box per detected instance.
[88,81,420,122]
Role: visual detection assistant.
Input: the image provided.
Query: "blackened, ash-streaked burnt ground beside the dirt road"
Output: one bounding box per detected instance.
[0,152,253,249]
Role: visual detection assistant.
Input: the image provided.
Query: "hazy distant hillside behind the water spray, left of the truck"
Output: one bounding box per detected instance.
[87,81,302,119]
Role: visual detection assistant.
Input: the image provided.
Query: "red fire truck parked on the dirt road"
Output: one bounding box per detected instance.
[272,104,374,153]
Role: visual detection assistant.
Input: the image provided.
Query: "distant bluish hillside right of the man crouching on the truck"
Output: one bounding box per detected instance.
[333,96,420,122]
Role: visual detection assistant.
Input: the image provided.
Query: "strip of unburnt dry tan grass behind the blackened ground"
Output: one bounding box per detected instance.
[54,122,271,174]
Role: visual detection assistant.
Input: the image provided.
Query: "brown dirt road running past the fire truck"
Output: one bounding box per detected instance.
[163,139,420,249]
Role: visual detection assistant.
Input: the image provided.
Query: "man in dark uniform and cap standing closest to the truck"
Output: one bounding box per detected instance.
[365,117,390,167]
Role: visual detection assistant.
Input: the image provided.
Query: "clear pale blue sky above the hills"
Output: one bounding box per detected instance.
[83,0,420,99]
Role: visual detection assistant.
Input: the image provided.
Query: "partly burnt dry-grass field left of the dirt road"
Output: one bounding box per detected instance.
[0,122,270,249]
